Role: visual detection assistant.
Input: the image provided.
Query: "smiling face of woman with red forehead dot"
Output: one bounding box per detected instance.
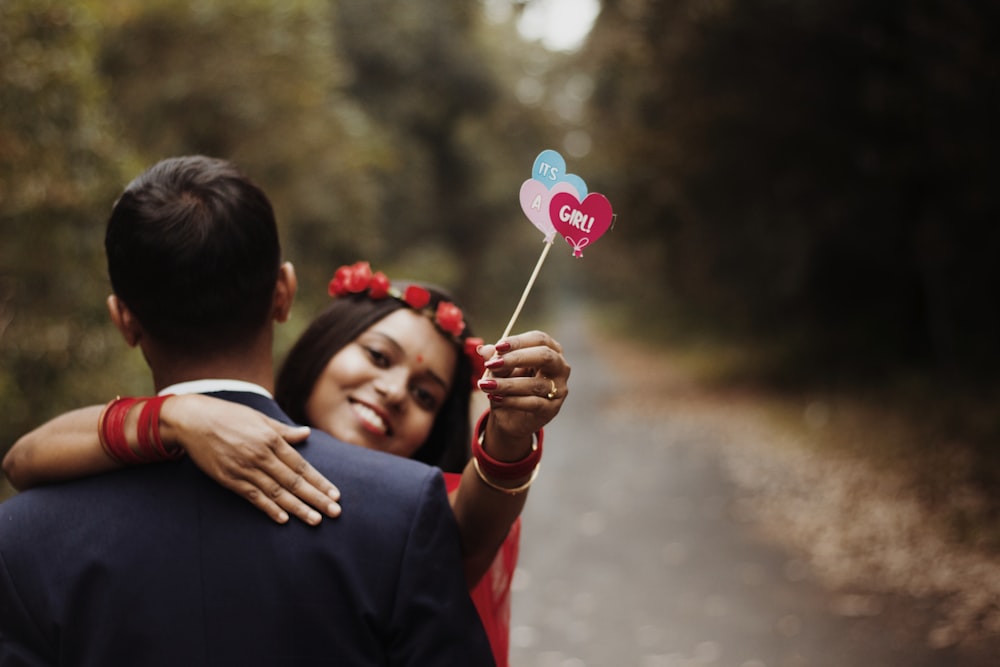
[306,308,457,458]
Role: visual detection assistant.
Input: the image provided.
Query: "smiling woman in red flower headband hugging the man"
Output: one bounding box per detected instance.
[4,262,570,665]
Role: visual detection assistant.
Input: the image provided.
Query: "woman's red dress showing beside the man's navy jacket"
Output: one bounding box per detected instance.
[444,472,521,667]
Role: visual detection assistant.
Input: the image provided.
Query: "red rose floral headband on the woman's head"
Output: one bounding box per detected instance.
[328,261,486,387]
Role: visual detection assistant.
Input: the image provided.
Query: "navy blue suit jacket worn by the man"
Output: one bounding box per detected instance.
[0,392,494,667]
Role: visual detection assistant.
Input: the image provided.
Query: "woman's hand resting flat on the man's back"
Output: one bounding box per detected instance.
[160,394,340,525]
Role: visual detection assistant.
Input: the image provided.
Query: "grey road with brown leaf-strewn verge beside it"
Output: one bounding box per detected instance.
[512,318,1000,667]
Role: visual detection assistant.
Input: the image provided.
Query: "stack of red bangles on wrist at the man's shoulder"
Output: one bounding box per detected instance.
[97,394,184,465]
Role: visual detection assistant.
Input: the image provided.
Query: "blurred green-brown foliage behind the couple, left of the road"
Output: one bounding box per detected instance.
[0,0,564,480]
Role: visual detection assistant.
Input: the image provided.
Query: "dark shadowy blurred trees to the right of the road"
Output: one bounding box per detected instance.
[588,0,1000,381]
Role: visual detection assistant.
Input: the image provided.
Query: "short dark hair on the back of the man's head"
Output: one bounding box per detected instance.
[104,156,281,355]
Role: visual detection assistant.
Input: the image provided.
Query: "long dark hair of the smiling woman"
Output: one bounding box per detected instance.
[275,284,472,472]
